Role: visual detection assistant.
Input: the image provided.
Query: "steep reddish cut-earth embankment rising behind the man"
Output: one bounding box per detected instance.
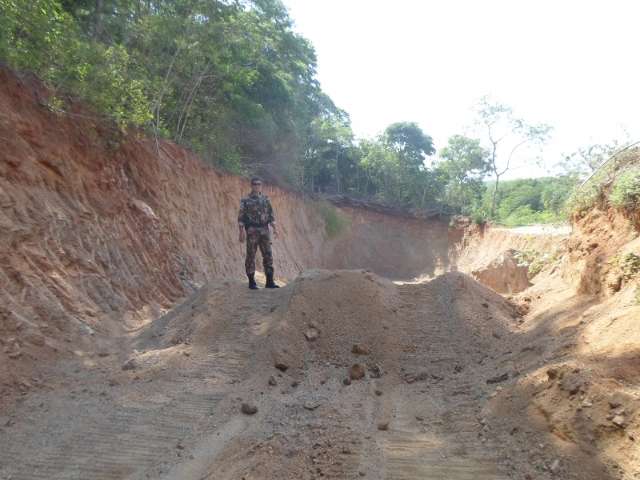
[0,69,448,398]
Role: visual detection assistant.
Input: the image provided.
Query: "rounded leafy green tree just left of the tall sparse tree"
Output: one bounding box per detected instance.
[438,135,490,213]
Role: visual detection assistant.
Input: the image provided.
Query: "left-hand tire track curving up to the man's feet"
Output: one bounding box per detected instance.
[0,286,278,480]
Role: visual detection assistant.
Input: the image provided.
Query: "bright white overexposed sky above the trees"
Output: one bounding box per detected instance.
[283,0,640,178]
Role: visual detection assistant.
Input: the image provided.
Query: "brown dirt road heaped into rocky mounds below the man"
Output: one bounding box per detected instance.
[0,271,616,480]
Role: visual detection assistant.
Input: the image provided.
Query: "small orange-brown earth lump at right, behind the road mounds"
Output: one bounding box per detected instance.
[471,249,531,294]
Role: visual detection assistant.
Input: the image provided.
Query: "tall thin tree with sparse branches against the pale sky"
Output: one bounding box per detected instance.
[476,96,552,217]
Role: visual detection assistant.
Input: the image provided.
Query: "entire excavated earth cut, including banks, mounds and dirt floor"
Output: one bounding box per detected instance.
[0,70,640,480]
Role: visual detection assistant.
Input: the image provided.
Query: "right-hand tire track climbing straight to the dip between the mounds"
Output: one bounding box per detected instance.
[382,282,508,480]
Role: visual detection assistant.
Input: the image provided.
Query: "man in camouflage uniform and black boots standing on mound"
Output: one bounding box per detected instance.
[238,177,280,290]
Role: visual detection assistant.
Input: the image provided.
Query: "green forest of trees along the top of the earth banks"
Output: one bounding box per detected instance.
[0,0,624,225]
